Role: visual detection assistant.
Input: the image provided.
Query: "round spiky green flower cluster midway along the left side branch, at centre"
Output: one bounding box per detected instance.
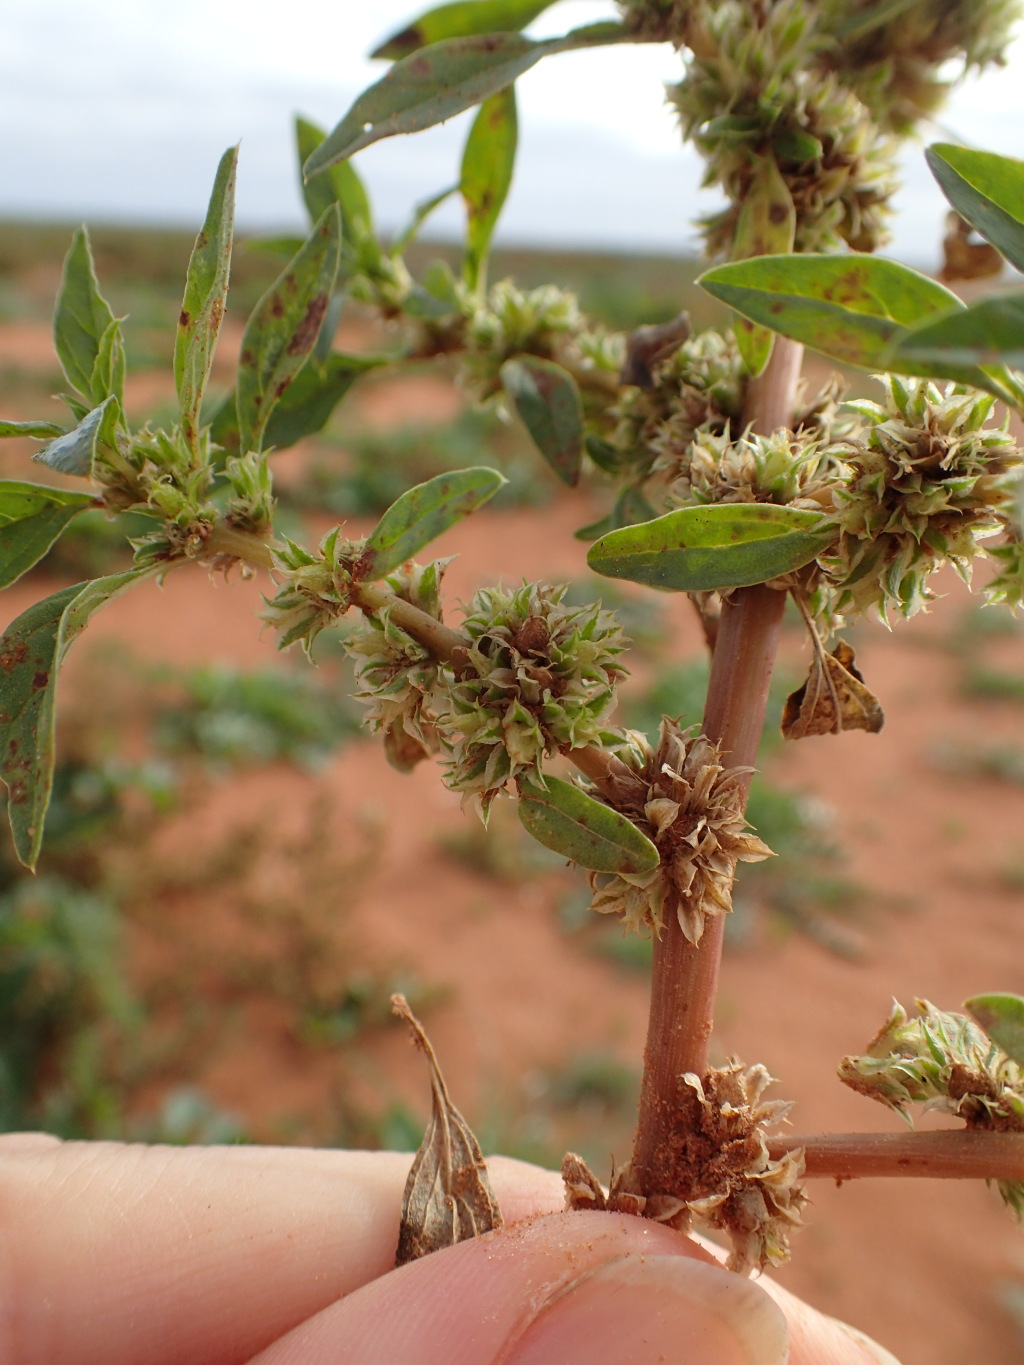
[437,583,625,816]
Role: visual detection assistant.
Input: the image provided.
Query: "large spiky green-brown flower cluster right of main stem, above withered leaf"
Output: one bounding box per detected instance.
[819,375,1021,620]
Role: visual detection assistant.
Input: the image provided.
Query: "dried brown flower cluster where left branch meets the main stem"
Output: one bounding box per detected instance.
[590,718,771,943]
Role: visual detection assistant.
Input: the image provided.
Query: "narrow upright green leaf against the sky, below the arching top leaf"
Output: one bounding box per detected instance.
[459,86,519,289]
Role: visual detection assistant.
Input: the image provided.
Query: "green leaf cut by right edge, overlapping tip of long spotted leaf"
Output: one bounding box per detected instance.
[887,293,1024,374]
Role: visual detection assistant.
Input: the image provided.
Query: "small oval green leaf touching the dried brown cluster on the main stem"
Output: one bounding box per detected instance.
[519,777,661,875]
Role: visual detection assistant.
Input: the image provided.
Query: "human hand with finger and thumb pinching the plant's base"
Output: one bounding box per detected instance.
[0,1134,896,1365]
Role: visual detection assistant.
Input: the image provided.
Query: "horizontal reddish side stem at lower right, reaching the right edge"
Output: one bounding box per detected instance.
[769,1132,1024,1181]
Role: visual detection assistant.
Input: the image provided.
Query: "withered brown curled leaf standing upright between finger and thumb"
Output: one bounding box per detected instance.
[390,995,502,1265]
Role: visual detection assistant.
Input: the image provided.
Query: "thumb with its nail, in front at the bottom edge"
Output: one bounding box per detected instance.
[253,1212,791,1365]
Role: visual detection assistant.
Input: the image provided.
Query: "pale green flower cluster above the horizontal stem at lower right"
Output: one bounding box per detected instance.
[840,1001,1024,1216]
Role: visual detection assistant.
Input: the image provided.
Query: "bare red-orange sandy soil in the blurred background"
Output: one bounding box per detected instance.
[0,328,1024,1365]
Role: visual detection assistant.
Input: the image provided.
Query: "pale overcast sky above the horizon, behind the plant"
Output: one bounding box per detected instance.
[0,0,1024,266]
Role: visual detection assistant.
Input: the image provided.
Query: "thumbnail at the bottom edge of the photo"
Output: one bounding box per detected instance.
[502,1256,788,1365]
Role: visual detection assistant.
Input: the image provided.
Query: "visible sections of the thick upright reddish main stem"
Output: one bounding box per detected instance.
[632,337,803,1193]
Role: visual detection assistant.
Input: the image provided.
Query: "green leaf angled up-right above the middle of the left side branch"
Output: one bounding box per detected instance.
[363,467,507,579]
